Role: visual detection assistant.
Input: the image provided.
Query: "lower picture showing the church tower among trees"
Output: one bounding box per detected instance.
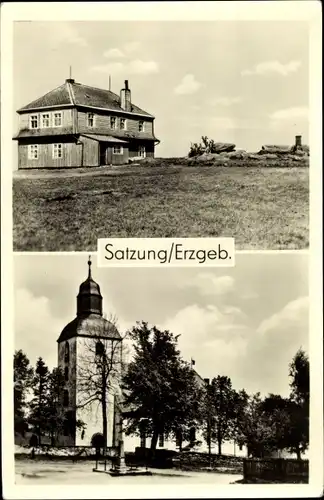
[13,252,309,485]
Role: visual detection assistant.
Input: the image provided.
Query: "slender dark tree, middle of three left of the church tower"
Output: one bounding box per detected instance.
[28,357,50,445]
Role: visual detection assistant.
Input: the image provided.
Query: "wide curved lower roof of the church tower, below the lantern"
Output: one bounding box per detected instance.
[57,314,121,342]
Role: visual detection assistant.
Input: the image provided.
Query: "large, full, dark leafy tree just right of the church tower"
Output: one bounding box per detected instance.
[123,322,200,455]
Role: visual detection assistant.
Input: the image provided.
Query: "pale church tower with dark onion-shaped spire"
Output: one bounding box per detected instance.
[57,257,122,447]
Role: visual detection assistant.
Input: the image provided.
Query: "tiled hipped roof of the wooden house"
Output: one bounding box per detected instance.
[18,79,154,118]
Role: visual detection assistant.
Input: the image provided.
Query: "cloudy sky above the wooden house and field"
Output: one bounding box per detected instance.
[14,21,309,156]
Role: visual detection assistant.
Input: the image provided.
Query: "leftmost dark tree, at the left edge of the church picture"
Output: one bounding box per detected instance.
[13,349,33,435]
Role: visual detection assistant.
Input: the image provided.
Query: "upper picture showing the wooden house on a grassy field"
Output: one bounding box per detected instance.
[11,21,311,252]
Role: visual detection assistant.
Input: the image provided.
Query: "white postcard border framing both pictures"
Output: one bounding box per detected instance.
[1,0,323,499]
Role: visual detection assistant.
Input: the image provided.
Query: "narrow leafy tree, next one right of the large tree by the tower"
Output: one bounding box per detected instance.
[209,375,237,455]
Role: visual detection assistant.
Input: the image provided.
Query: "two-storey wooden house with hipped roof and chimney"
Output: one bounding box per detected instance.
[14,78,159,169]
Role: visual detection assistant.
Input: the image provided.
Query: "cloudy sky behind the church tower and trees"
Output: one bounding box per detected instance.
[14,253,308,395]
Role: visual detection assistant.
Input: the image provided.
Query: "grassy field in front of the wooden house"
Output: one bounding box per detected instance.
[13,166,309,251]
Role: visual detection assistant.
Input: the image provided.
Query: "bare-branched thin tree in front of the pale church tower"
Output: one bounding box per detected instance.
[77,316,129,447]
